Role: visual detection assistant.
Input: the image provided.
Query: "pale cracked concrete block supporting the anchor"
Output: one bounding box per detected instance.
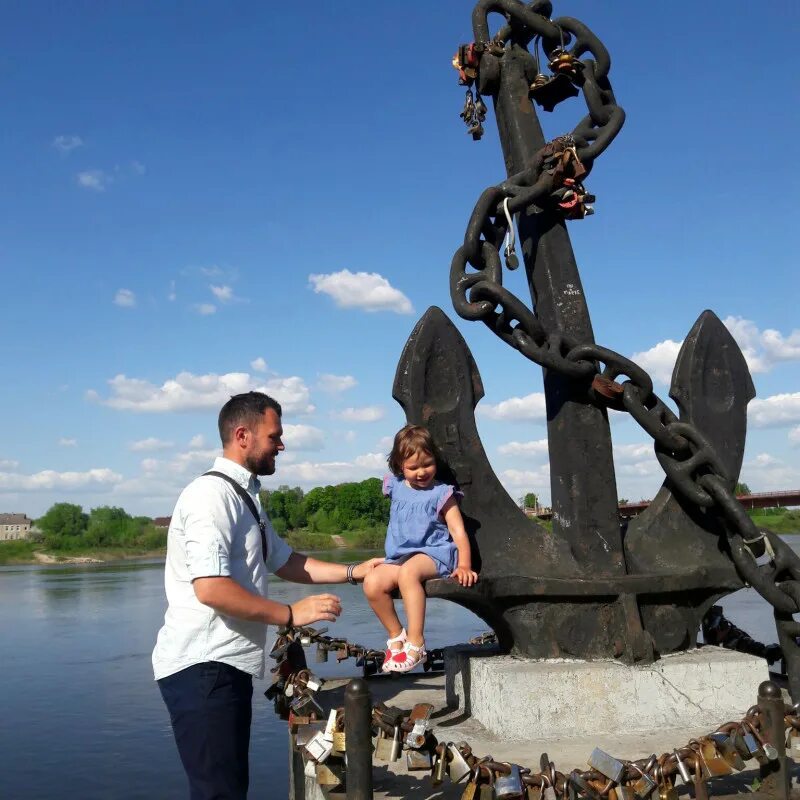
[445,646,769,740]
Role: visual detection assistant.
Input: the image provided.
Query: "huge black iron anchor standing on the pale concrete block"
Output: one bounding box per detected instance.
[393,0,754,662]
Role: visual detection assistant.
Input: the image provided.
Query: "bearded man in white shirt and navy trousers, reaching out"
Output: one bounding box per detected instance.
[153,392,381,800]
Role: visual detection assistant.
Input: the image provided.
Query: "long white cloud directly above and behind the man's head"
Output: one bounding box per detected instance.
[86,372,314,414]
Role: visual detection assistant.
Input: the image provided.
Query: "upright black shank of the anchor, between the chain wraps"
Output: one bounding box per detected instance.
[494,42,625,574]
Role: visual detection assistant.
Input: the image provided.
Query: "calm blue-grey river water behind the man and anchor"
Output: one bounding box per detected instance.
[0,556,788,800]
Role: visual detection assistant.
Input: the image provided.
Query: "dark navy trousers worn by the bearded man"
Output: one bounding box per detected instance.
[158,661,253,800]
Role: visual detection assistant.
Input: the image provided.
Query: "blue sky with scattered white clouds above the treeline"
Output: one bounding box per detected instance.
[0,0,800,516]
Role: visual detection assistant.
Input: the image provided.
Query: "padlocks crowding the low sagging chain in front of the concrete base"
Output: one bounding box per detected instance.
[291,680,800,800]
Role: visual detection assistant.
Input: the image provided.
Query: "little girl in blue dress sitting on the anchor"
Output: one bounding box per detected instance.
[364,425,478,672]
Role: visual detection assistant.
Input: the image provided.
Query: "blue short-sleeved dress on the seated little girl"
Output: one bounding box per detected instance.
[383,475,463,578]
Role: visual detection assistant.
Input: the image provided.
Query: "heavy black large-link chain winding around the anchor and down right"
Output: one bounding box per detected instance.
[450,0,800,699]
